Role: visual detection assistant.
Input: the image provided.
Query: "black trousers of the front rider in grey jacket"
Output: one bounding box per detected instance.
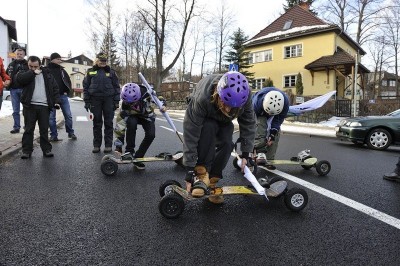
[197,119,234,178]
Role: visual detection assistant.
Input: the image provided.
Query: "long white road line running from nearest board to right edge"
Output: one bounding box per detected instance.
[266,166,400,229]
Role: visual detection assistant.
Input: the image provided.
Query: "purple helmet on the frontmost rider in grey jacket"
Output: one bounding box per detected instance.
[217,71,249,108]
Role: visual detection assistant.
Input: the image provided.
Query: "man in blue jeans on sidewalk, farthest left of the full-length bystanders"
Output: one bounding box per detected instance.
[6,48,28,134]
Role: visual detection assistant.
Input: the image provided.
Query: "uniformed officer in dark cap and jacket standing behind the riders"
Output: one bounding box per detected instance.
[83,53,120,153]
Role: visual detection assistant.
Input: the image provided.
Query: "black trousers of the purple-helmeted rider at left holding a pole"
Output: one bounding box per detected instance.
[125,116,156,158]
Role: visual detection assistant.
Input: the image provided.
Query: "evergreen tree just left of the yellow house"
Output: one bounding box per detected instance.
[225,28,254,84]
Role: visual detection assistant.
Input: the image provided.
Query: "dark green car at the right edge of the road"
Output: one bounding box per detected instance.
[335,109,400,150]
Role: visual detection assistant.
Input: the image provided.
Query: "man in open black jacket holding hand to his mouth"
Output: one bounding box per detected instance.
[16,56,60,159]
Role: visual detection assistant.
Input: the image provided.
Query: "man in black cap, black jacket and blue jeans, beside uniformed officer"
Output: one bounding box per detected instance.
[47,53,76,141]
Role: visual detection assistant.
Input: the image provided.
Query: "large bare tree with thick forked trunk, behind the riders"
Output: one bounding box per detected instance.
[138,0,196,90]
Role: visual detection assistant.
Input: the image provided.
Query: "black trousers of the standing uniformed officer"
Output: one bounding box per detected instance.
[90,96,114,147]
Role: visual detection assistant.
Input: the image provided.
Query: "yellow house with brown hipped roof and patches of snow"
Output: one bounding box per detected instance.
[245,5,369,99]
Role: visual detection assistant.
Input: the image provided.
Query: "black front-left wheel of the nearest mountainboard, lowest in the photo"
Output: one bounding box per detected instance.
[158,193,185,219]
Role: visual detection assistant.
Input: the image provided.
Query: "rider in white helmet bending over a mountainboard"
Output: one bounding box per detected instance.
[252,87,289,170]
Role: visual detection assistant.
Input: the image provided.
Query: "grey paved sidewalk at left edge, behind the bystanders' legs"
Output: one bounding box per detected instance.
[0,111,64,161]
